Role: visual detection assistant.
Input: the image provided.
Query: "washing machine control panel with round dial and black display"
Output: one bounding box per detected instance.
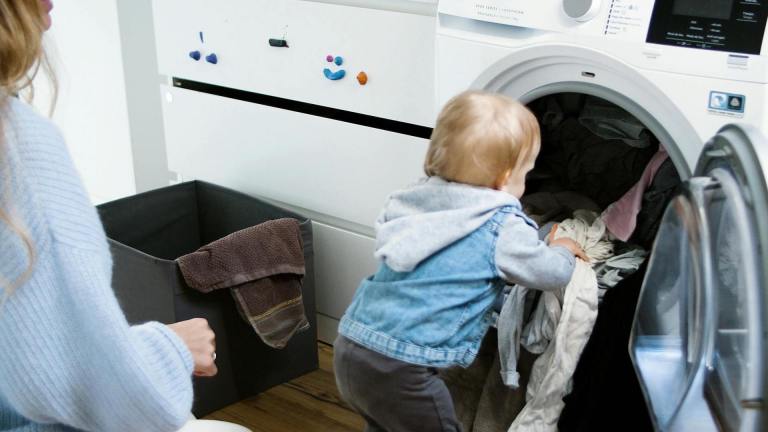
[438,0,768,55]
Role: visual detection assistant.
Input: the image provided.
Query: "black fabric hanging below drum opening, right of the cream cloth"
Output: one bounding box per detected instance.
[557,264,653,432]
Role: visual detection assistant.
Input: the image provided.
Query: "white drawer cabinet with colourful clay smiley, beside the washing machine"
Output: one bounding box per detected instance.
[153,0,435,342]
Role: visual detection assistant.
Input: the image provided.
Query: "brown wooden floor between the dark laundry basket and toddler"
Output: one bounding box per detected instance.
[205,343,365,432]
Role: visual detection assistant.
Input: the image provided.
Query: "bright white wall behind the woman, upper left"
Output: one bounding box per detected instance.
[35,0,136,203]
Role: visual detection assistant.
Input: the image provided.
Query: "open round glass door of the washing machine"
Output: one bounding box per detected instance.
[630,125,768,431]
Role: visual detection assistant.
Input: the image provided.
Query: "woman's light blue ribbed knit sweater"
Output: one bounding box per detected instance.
[0,99,193,432]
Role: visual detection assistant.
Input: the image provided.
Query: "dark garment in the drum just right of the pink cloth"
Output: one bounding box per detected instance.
[630,159,682,250]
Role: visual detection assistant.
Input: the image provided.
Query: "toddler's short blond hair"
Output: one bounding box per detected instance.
[424,91,541,187]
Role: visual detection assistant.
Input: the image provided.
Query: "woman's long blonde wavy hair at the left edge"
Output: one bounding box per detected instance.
[0,0,56,299]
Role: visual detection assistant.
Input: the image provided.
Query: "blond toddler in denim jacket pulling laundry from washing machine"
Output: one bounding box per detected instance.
[334,91,586,432]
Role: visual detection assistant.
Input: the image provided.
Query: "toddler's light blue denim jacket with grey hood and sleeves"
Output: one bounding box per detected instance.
[339,177,575,367]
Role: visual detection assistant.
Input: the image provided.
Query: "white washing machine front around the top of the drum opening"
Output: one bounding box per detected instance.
[435,0,768,431]
